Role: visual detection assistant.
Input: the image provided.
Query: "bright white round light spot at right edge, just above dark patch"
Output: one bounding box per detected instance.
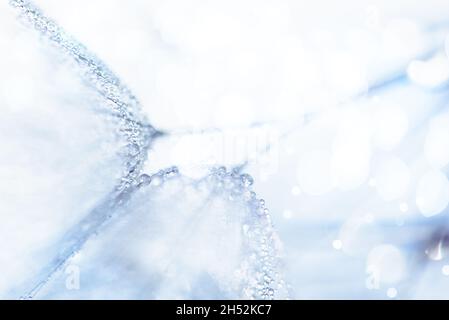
[416,170,449,217]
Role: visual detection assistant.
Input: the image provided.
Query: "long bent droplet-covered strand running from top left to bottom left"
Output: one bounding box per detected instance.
[10,0,160,298]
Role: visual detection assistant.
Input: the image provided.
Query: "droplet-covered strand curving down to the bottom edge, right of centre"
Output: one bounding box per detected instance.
[208,167,289,299]
